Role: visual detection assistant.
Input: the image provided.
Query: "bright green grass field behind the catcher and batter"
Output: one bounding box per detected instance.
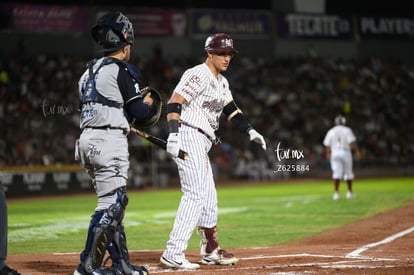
[6,178,414,254]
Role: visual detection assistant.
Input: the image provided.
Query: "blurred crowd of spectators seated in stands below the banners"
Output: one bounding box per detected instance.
[0,47,414,183]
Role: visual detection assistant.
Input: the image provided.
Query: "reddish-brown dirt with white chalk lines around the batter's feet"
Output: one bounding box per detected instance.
[8,202,414,275]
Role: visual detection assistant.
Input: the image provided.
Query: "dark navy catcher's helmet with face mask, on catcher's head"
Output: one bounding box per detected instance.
[91,11,134,52]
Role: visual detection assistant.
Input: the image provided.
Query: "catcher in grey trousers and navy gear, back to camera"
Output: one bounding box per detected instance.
[74,12,161,275]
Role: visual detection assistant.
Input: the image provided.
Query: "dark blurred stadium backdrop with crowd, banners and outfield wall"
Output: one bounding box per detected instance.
[0,0,414,197]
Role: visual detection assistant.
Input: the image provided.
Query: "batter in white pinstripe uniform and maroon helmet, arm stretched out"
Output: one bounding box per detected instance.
[160,33,266,270]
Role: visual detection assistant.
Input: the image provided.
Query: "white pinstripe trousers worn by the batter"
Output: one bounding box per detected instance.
[163,125,218,261]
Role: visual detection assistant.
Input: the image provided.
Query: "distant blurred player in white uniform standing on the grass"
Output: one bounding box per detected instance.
[323,115,358,200]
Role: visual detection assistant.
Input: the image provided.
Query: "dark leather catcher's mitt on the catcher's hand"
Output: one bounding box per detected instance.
[131,86,162,129]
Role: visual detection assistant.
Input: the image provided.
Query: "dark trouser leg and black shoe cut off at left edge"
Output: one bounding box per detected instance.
[0,182,20,275]
